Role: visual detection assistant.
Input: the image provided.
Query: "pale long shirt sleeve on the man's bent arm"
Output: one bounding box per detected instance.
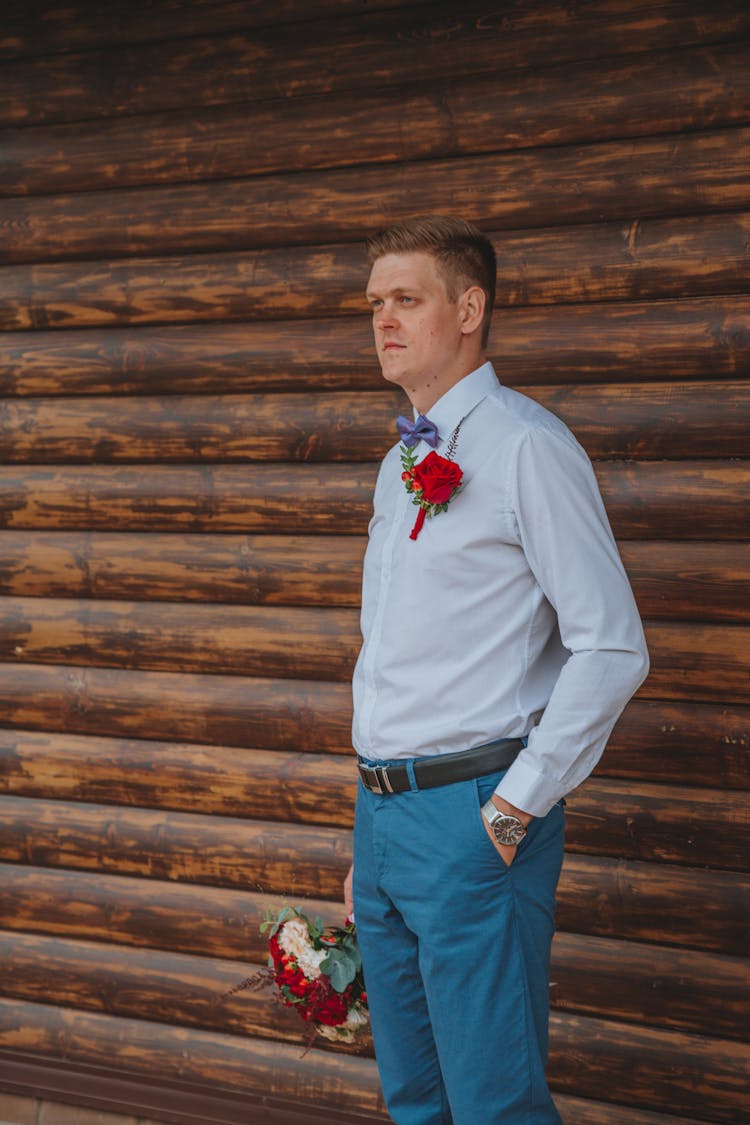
[496,426,649,817]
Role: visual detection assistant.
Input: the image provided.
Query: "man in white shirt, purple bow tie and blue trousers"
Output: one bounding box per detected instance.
[345,216,648,1125]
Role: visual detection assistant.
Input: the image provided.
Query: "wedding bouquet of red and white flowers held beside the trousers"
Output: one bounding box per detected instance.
[232,907,369,1043]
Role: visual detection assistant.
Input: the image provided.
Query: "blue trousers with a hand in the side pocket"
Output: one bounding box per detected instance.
[354,773,564,1125]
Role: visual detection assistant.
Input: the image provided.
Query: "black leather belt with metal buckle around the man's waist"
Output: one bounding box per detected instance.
[358,738,524,794]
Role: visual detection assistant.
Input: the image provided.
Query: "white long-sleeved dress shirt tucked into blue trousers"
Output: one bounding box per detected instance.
[353,363,649,816]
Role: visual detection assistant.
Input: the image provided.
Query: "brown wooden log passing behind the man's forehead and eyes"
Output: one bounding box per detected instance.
[0,211,750,321]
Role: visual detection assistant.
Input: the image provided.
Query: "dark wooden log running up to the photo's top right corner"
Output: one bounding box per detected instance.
[0,0,750,125]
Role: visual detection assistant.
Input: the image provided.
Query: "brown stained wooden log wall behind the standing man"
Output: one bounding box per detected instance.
[0,0,750,1125]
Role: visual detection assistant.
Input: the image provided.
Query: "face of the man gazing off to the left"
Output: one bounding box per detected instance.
[367,253,463,402]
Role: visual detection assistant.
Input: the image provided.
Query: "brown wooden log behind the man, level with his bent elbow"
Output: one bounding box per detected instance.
[0,597,750,702]
